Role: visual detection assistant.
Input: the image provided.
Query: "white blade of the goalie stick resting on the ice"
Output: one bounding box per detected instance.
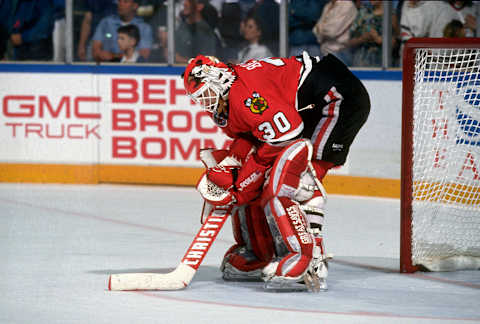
[108,263,196,291]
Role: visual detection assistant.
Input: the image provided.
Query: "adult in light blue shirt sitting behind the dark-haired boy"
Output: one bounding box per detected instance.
[92,0,153,62]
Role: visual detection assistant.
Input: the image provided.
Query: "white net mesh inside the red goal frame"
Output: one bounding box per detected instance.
[412,48,480,265]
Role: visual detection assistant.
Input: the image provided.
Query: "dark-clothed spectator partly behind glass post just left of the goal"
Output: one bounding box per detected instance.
[349,0,398,67]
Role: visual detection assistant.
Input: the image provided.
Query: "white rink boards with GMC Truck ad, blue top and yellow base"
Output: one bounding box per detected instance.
[0,64,401,198]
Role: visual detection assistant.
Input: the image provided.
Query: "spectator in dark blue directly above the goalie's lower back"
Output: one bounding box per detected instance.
[288,0,327,56]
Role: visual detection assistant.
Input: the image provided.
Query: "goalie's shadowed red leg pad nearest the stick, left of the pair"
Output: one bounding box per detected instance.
[220,205,274,280]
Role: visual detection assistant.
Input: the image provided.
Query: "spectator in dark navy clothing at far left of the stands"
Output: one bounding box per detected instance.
[10,0,54,61]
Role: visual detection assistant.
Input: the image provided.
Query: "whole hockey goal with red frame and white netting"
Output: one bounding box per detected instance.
[400,38,480,273]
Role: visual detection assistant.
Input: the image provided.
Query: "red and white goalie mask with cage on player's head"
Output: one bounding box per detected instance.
[183,55,235,116]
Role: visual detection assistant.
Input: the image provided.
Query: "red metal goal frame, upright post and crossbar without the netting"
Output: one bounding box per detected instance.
[400,38,480,273]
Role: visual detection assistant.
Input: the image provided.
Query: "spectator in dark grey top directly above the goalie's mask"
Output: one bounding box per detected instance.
[175,0,217,63]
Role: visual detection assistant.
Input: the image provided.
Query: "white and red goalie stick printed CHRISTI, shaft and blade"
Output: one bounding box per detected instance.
[108,203,234,290]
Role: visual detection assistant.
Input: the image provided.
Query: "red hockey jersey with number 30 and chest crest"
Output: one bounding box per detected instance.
[224,57,303,144]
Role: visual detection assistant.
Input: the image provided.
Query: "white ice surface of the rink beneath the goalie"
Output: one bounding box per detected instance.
[0,183,480,324]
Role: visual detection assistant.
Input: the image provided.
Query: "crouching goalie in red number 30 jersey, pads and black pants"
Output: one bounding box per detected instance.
[183,52,370,291]
